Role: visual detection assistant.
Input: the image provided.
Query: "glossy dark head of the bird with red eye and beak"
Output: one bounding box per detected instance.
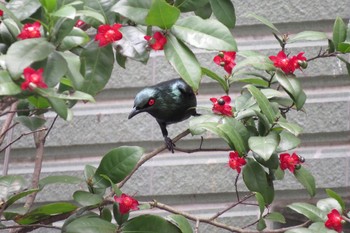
[128,87,157,119]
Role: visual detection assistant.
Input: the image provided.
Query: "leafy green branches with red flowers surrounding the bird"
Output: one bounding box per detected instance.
[0,0,350,233]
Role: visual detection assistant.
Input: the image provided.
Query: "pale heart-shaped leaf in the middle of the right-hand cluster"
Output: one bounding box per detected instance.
[248,131,279,161]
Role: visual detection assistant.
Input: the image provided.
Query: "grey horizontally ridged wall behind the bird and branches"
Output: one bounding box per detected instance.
[0,0,350,232]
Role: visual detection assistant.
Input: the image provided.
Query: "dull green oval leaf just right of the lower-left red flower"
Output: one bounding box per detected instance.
[43,51,68,87]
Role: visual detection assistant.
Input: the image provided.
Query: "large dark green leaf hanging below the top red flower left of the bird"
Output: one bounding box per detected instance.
[80,42,114,96]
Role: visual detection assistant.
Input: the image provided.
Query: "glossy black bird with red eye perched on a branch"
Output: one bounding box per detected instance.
[128,79,198,153]
